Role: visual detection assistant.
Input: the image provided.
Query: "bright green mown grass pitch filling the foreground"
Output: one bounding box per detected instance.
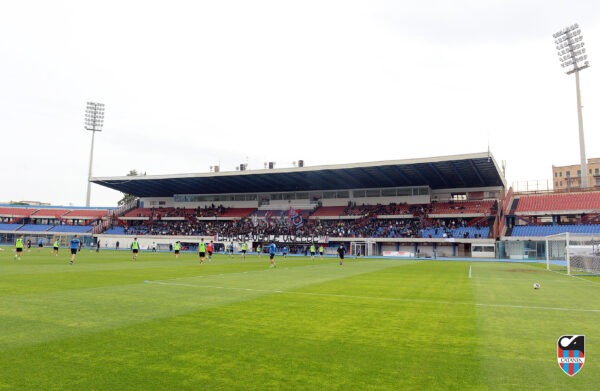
[0,247,600,390]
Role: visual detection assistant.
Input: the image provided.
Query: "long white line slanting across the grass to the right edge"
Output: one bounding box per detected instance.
[144,280,600,313]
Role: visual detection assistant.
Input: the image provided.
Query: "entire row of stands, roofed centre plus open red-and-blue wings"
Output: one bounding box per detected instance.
[0,152,600,259]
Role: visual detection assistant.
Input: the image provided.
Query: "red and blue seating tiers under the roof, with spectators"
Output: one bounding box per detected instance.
[95,200,495,238]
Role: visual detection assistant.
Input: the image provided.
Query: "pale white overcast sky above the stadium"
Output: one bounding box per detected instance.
[0,0,600,206]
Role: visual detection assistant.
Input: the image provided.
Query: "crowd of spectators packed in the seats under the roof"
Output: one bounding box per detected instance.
[110,204,490,238]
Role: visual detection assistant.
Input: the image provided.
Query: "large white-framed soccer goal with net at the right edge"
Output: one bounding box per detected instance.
[546,232,600,275]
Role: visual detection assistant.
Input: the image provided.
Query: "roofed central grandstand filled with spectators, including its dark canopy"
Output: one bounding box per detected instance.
[92,152,506,257]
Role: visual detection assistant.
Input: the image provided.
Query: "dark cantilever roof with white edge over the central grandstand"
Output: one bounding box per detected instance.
[92,152,505,197]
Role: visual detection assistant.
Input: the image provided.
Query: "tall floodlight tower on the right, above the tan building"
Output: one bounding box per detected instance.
[552,23,590,188]
